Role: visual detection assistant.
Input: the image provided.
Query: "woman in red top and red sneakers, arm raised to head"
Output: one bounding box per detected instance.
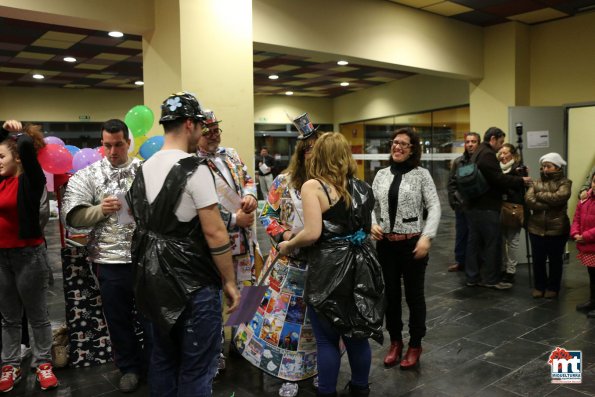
[0,120,58,392]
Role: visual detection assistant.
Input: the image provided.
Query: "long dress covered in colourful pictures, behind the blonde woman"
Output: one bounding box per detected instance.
[234,174,317,381]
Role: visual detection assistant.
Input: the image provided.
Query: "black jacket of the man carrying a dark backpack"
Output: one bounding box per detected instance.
[468,142,525,211]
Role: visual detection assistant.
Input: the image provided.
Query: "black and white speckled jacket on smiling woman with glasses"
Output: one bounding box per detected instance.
[372,167,441,238]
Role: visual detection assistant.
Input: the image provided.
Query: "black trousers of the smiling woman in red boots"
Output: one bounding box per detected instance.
[376,237,428,347]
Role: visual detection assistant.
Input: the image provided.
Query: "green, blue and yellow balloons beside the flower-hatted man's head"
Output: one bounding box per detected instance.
[124,105,163,160]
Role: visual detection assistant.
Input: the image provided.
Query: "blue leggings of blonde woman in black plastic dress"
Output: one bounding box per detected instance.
[308,305,372,394]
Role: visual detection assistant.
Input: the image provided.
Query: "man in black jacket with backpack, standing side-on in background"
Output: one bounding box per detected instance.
[465,127,531,289]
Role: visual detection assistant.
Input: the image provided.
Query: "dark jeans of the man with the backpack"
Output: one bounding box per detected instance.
[465,209,502,285]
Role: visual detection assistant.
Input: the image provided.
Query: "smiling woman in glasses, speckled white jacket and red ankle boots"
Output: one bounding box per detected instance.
[372,128,440,369]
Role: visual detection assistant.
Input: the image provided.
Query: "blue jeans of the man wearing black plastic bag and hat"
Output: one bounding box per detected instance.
[149,286,222,397]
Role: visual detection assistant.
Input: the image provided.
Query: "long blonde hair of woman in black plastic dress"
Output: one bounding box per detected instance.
[307,132,357,207]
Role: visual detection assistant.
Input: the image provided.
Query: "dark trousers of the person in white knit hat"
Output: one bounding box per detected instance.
[529,233,568,292]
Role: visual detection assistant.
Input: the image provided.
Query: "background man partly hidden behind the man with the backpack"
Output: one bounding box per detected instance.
[447,132,481,272]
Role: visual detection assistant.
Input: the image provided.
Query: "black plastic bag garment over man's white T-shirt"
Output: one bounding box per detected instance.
[126,157,221,332]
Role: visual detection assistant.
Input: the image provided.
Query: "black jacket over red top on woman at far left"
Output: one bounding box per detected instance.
[0,128,45,239]
